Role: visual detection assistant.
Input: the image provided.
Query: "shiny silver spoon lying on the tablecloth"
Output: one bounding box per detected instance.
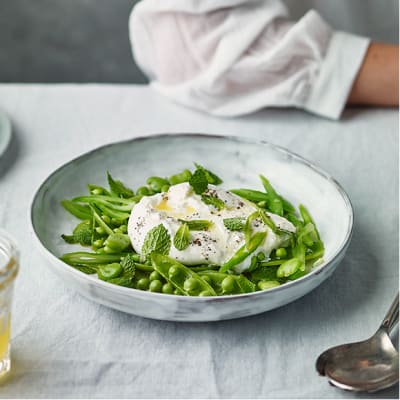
[316,296,399,392]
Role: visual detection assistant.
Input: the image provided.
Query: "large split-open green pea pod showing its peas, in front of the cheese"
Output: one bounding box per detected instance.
[151,252,217,296]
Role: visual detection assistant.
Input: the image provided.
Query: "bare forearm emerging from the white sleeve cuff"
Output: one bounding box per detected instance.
[347,43,399,107]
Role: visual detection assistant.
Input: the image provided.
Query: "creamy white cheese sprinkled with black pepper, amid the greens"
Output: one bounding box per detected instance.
[128,183,296,272]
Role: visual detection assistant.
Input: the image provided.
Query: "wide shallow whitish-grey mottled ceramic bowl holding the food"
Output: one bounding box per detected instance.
[31,134,353,321]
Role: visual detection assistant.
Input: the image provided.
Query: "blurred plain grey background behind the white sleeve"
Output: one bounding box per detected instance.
[0,0,399,83]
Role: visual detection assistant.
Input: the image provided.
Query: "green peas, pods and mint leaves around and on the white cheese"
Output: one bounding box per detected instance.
[60,164,324,296]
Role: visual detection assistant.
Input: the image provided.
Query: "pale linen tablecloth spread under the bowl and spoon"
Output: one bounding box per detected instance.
[0,84,398,399]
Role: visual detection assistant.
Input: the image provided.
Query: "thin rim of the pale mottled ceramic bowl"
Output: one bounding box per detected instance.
[29,132,354,303]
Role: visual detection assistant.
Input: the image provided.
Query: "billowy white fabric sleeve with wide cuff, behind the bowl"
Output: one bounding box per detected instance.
[129,0,369,119]
